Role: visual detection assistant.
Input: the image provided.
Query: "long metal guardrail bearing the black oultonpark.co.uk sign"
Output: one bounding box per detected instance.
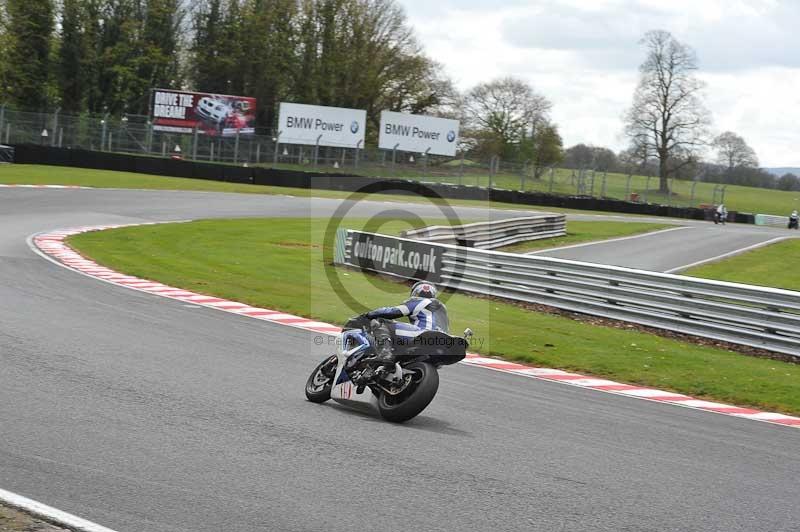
[336,230,800,357]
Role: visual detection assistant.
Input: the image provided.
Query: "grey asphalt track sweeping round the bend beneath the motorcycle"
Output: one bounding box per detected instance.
[0,189,800,532]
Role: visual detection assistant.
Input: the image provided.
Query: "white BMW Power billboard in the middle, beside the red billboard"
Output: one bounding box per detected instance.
[278,102,367,148]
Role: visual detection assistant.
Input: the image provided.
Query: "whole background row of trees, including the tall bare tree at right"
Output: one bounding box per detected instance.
[0,0,795,191]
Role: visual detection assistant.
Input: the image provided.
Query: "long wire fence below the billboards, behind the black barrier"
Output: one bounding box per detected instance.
[0,106,725,207]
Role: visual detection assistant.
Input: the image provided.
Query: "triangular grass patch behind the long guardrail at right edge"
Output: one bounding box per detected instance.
[682,239,800,290]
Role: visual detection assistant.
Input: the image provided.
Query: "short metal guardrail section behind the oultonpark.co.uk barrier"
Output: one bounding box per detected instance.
[401,213,567,249]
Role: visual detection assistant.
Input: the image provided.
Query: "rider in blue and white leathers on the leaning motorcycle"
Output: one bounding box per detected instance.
[362,281,450,365]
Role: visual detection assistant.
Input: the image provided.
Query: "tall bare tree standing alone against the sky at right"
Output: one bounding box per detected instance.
[625,30,710,192]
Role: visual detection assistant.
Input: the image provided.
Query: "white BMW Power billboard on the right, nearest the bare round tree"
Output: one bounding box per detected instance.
[378,111,460,157]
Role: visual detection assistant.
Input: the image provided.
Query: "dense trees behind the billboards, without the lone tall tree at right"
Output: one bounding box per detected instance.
[0,0,562,165]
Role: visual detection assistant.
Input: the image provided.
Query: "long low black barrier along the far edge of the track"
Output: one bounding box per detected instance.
[10,144,753,223]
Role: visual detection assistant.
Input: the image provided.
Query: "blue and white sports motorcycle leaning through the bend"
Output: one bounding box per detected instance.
[306,316,472,423]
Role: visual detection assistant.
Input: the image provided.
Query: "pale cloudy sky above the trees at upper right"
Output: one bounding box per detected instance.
[399,0,800,167]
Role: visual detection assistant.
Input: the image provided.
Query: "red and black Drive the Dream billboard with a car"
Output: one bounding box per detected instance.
[150,89,256,136]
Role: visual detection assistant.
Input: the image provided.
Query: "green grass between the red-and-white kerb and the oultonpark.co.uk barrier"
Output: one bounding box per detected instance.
[70,219,800,414]
